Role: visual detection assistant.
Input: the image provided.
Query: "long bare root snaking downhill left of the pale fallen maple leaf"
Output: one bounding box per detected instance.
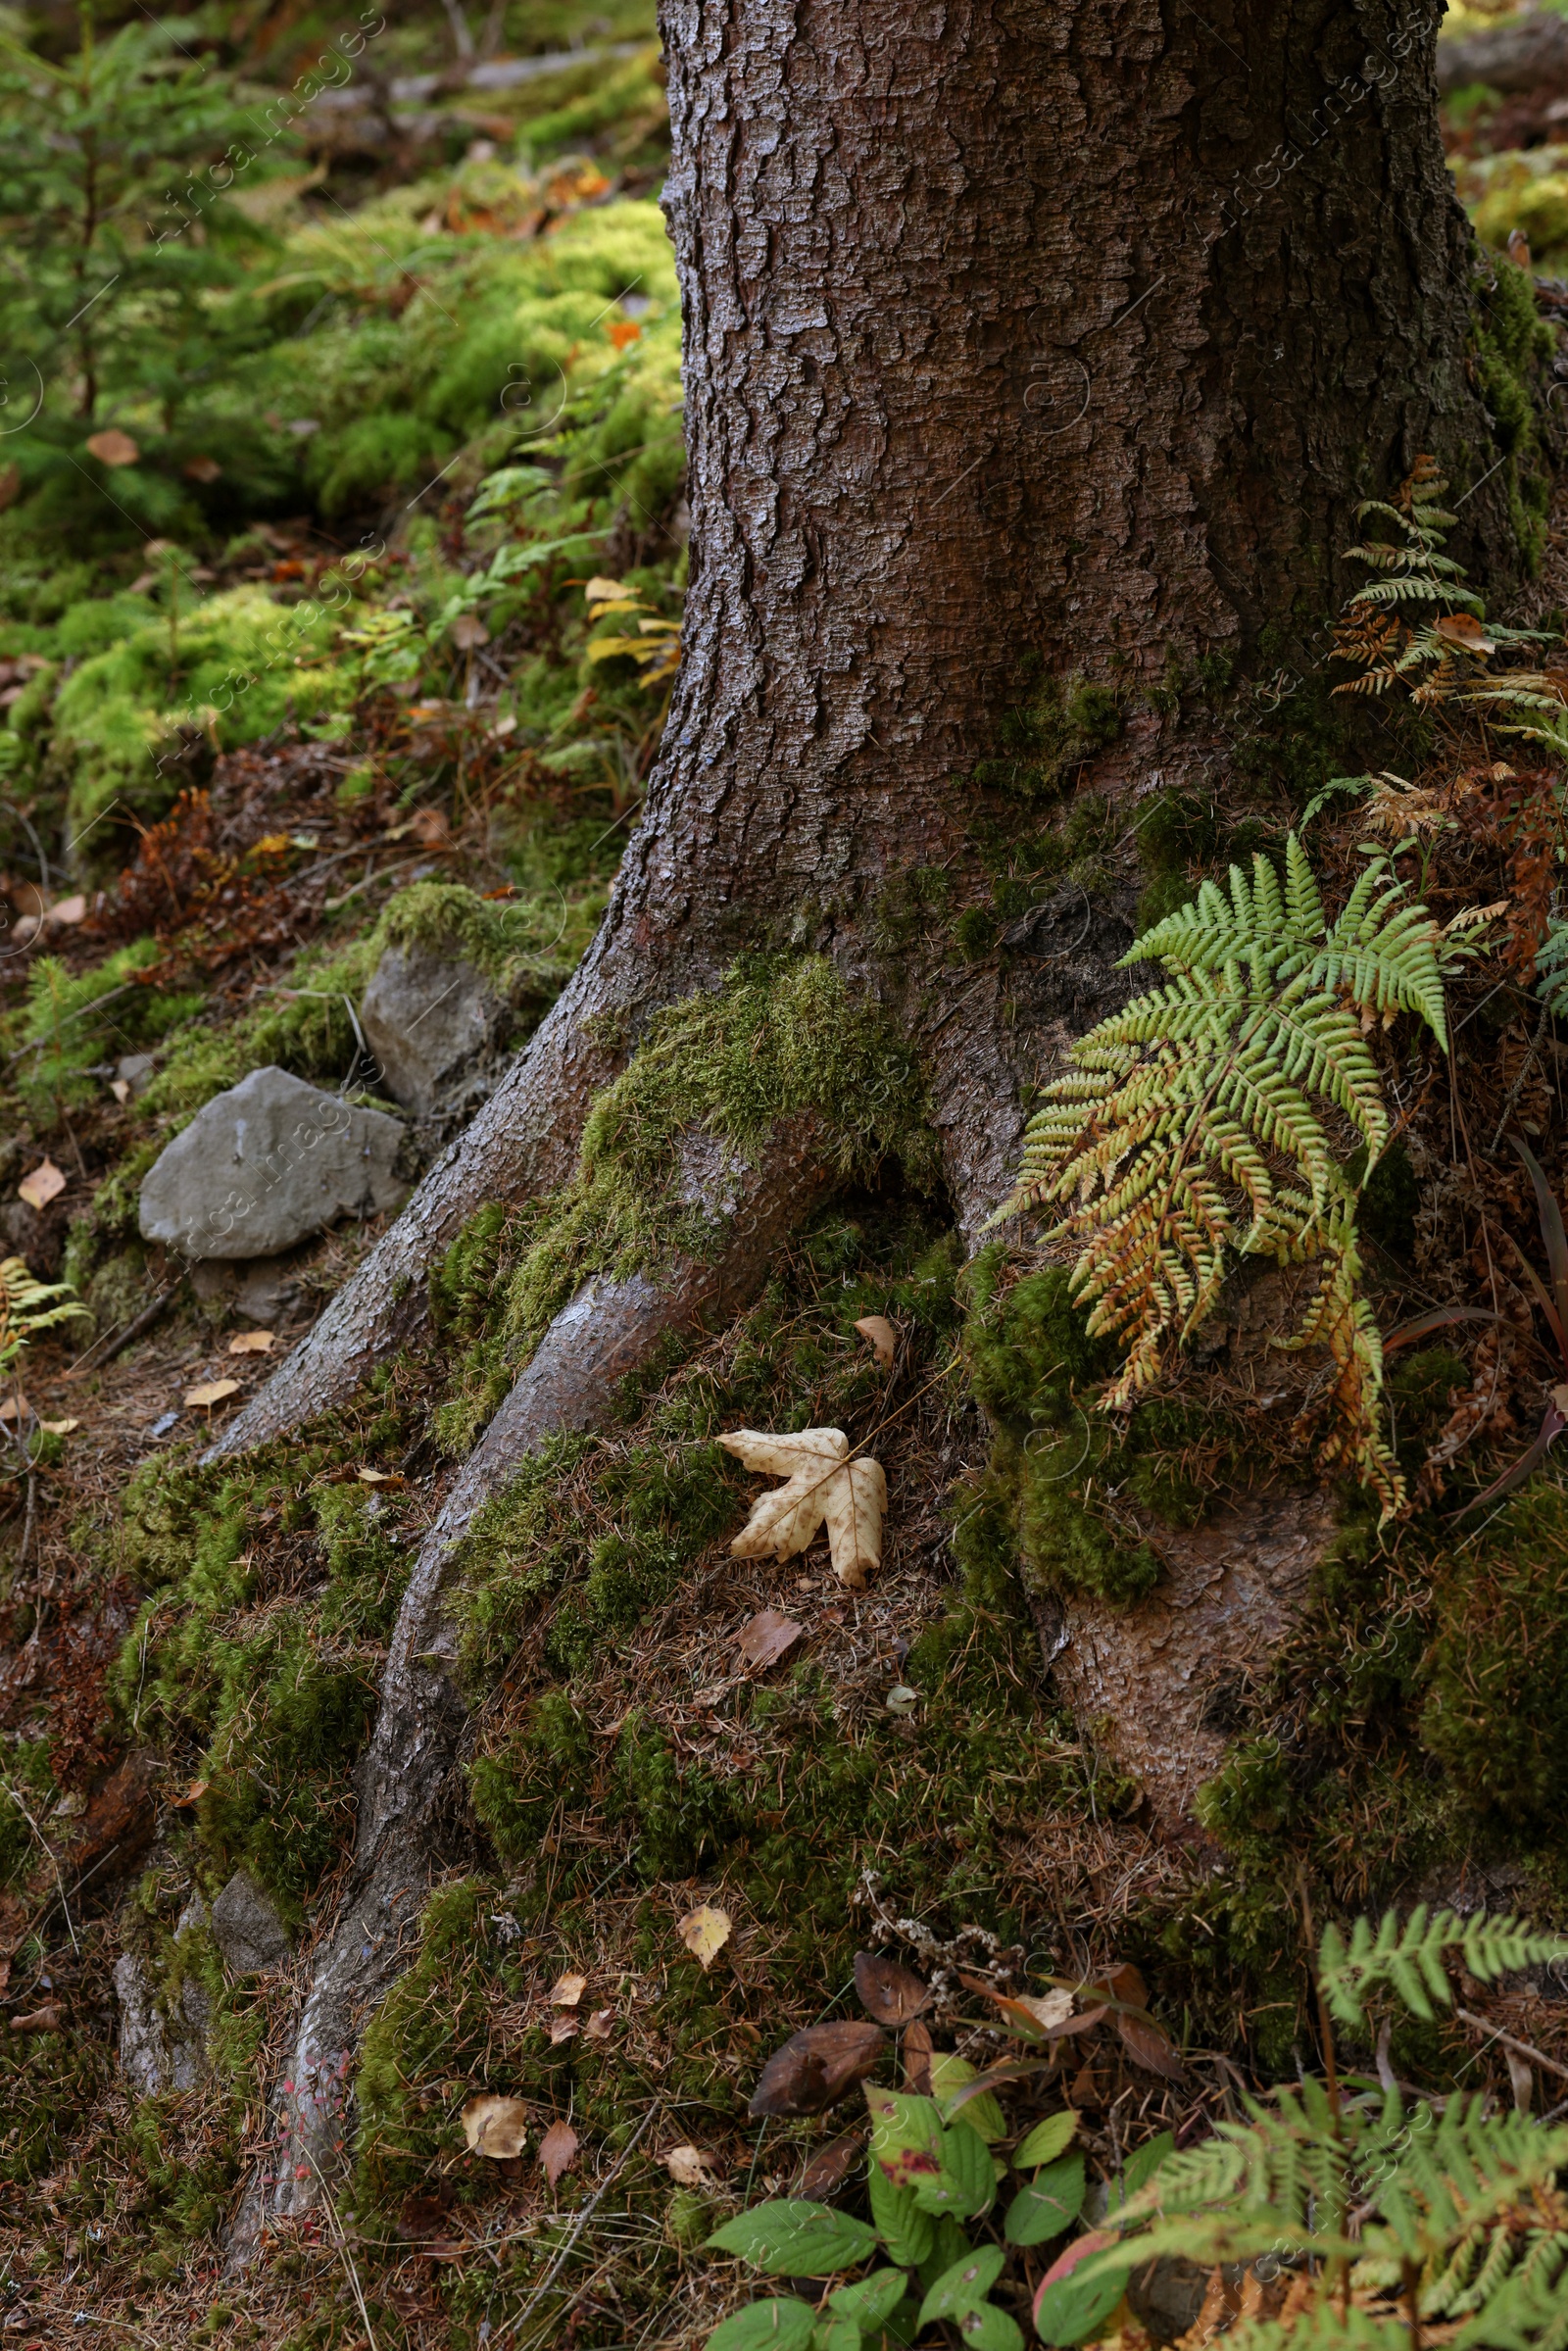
[232,1112,830,2259]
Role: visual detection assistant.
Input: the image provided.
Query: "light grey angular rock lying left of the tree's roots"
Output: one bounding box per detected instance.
[141,1070,405,1257]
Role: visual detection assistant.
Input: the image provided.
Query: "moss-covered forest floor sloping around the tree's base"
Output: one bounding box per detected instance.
[0,0,1568,2351]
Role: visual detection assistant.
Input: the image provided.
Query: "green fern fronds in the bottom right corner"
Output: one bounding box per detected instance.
[1071,1907,1568,2351]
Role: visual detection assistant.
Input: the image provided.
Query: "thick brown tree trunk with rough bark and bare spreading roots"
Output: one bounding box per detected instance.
[217,0,1514,2210]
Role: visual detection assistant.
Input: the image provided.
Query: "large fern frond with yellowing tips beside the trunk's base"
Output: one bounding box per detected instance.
[997,835,1448,1516]
